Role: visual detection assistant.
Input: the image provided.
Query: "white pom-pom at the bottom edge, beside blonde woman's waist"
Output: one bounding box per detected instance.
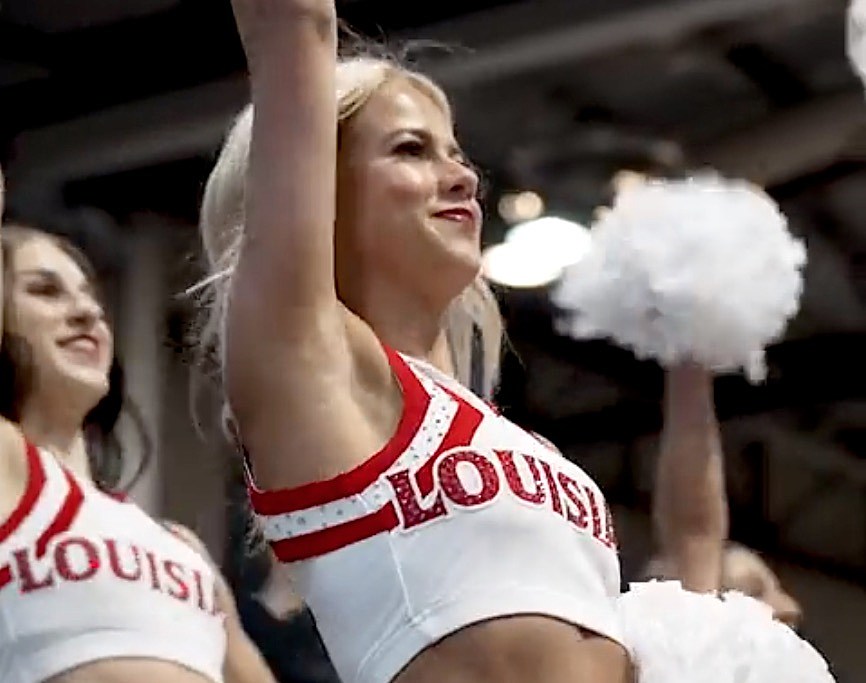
[618,581,834,683]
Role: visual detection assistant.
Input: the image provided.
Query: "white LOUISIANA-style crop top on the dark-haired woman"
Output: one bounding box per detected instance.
[0,445,226,683]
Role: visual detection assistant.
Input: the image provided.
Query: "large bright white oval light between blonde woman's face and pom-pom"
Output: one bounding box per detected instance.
[483,216,591,288]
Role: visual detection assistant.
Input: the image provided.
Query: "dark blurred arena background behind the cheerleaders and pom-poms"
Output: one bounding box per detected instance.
[0,0,866,681]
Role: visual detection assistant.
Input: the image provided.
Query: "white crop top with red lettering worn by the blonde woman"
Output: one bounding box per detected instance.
[248,349,621,683]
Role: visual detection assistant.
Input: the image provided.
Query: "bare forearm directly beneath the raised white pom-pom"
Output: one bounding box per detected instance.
[653,365,728,592]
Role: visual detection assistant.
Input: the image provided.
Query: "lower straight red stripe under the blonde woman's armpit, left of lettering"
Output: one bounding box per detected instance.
[271,503,399,562]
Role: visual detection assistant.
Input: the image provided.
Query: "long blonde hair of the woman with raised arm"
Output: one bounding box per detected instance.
[193,57,503,398]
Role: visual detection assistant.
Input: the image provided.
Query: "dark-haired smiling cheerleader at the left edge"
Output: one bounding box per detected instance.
[0,171,273,683]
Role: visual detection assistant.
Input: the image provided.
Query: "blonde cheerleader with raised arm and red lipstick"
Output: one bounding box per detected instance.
[194,0,823,683]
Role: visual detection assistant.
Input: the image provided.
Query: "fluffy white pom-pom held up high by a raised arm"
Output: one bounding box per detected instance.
[552,175,806,381]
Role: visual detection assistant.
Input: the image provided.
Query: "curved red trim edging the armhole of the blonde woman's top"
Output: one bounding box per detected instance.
[247,344,430,515]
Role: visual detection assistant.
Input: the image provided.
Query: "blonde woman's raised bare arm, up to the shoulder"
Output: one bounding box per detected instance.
[218,0,345,438]
